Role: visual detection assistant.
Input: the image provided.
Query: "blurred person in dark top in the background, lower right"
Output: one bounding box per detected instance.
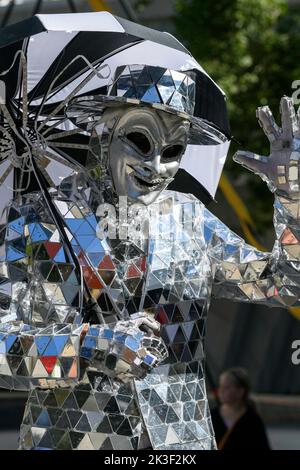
[212,367,270,450]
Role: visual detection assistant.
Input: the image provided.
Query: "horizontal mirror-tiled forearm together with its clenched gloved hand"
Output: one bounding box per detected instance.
[0,316,167,390]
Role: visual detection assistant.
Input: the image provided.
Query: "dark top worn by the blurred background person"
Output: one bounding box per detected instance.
[211,406,270,450]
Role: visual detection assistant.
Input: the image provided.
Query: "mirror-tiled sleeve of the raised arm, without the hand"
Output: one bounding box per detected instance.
[204,197,300,307]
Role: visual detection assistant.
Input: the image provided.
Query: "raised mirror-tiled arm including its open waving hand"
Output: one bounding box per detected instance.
[210,97,300,306]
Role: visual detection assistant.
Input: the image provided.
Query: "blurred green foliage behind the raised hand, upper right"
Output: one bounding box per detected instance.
[176,0,300,229]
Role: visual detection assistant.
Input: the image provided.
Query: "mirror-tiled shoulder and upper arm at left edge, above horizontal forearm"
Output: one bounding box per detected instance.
[0,192,80,325]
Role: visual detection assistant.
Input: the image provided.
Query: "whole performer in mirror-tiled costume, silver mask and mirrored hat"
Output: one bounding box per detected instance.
[0,21,300,450]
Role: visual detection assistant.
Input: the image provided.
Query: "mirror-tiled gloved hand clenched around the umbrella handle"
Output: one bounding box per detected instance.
[80,312,168,382]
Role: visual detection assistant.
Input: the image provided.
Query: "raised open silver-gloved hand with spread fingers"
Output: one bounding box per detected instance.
[233,96,300,200]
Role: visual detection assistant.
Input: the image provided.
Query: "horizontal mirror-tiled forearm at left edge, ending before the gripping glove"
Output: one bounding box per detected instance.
[0,322,82,390]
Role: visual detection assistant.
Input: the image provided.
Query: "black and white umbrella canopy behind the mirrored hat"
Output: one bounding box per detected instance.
[0,8,230,206]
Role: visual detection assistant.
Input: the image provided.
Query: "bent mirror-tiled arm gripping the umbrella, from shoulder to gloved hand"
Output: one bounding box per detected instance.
[0,193,166,390]
